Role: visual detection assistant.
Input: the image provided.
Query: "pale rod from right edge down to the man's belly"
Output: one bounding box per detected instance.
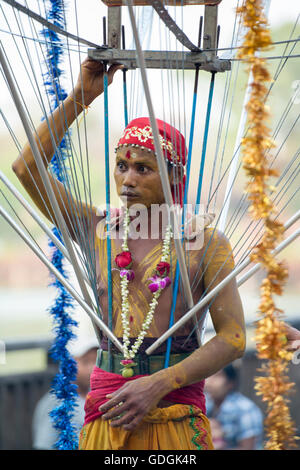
[146,210,300,354]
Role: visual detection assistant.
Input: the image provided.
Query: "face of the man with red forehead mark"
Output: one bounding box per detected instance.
[114,147,170,208]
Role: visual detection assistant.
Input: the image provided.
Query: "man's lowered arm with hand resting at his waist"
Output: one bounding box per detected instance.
[100,230,245,430]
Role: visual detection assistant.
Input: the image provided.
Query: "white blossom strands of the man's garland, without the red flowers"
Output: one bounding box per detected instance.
[120,208,172,360]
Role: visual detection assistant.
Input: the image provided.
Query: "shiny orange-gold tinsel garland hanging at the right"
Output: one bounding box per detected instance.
[238,0,295,450]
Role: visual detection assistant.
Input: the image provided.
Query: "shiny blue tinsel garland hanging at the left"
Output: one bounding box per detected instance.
[42,0,78,450]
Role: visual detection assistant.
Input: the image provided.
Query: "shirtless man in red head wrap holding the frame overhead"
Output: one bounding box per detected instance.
[13,59,296,450]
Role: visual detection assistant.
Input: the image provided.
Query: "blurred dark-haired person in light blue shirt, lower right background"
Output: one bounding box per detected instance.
[205,364,263,450]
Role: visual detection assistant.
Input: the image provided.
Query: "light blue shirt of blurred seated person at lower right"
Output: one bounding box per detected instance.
[205,392,263,449]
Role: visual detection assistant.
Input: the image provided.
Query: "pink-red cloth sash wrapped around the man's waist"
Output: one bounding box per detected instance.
[84,366,206,425]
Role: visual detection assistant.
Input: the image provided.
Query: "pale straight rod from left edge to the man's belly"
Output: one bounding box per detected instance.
[0,206,123,352]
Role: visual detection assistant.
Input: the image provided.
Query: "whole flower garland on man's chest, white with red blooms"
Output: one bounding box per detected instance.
[115,208,172,377]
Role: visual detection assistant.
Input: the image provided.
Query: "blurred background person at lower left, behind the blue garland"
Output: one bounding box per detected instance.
[32,337,98,450]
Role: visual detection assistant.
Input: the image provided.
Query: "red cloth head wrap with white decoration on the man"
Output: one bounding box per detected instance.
[117,117,187,205]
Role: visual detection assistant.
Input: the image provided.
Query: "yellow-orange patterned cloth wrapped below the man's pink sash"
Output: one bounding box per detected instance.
[79,405,213,450]
